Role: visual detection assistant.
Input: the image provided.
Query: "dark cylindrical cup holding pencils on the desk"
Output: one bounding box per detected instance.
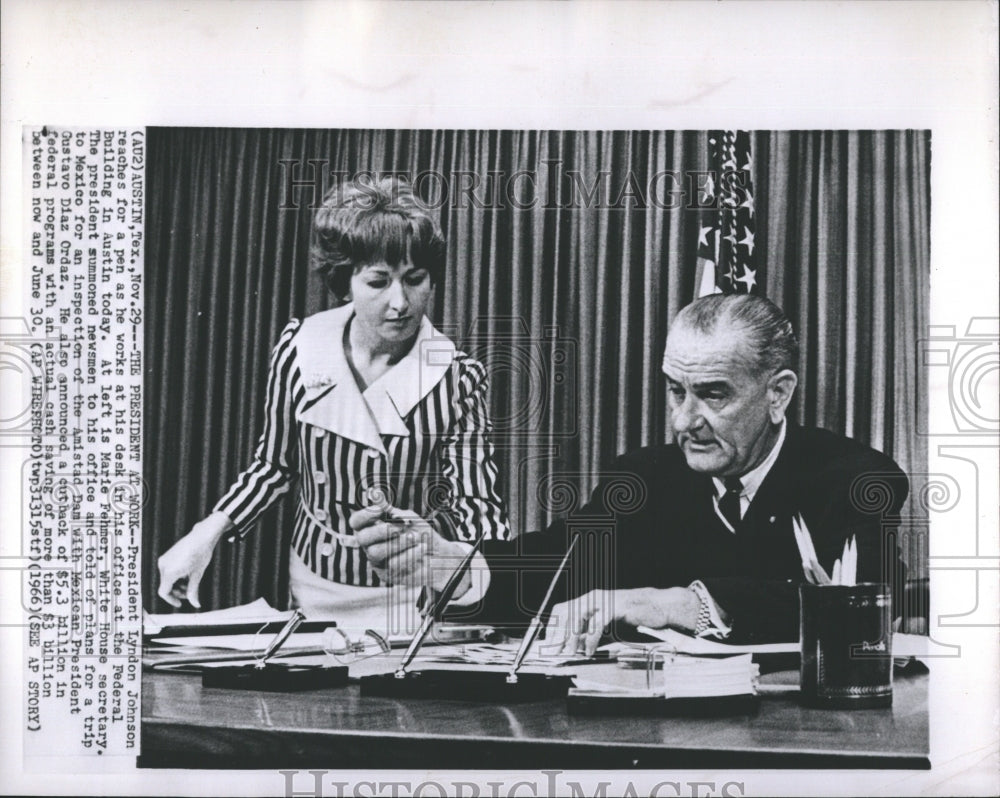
[799,583,892,709]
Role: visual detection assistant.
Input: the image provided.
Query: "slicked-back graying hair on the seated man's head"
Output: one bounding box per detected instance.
[671,294,799,374]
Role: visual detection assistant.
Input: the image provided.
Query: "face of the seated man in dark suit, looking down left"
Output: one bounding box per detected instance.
[663,324,777,477]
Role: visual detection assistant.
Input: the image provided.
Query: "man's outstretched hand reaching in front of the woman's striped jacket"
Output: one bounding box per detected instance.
[348,505,472,598]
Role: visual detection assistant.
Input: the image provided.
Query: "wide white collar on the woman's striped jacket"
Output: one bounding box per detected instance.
[295,304,455,454]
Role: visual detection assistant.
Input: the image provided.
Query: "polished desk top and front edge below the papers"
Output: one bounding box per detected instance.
[139,672,930,770]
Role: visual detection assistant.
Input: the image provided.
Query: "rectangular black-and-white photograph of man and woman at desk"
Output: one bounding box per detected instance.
[140,129,931,769]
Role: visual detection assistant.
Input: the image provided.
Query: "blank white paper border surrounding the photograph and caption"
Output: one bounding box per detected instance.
[0,0,1000,795]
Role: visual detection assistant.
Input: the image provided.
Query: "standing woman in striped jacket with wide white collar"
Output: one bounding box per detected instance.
[158,178,510,632]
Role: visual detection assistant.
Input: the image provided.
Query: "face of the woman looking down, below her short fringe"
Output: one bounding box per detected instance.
[351,262,433,343]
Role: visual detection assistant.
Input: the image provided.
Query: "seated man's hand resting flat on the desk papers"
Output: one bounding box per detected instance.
[543,587,701,657]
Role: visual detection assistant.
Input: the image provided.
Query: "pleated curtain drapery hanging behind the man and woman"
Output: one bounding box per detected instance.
[143,128,930,610]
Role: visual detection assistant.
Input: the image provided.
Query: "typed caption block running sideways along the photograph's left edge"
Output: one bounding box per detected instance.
[22,128,145,757]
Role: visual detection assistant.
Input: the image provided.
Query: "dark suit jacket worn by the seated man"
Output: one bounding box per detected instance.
[472,422,909,642]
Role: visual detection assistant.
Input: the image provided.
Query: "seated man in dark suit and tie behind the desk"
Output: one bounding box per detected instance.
[480,295,909,654]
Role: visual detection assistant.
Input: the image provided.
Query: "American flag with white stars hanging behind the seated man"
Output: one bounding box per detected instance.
[695,130,764,296]
